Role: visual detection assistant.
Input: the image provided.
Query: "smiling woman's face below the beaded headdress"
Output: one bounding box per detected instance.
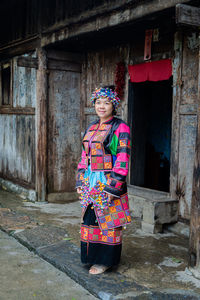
[95,98,113,120]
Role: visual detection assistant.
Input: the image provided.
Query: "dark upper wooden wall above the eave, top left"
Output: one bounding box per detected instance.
[0,0,139,46]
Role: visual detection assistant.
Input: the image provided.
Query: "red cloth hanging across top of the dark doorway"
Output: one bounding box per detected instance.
[128,59,172,82]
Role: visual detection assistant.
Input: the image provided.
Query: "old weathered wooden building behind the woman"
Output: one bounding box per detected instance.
[0,0,200,266]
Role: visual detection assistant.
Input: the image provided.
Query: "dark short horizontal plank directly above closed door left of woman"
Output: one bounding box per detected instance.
[48,59,81,73]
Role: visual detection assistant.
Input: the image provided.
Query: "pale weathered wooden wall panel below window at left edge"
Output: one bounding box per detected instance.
[0,115,35,187]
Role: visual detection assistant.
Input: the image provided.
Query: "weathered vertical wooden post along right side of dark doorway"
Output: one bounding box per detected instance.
[170,32,183,199]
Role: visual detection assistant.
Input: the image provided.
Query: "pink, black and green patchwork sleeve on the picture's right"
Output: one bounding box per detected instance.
[104,123,131,197]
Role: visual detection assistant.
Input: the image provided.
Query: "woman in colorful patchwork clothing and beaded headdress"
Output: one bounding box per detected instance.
[76,87,131,275]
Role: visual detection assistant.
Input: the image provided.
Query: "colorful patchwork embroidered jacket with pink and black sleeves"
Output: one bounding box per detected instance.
[76,117,131,232]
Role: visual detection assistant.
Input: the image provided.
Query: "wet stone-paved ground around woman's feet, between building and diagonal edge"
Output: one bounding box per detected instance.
[0,190,200,300]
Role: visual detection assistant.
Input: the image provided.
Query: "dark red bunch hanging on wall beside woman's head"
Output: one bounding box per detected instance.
[115,62,125,99]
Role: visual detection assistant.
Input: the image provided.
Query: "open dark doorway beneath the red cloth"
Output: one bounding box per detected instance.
[129,79,172,192]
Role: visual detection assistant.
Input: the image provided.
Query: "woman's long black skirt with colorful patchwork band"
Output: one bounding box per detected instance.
[81,204,122,267]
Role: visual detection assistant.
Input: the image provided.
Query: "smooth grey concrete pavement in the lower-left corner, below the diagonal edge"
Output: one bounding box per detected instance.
[0,231,97,300]
